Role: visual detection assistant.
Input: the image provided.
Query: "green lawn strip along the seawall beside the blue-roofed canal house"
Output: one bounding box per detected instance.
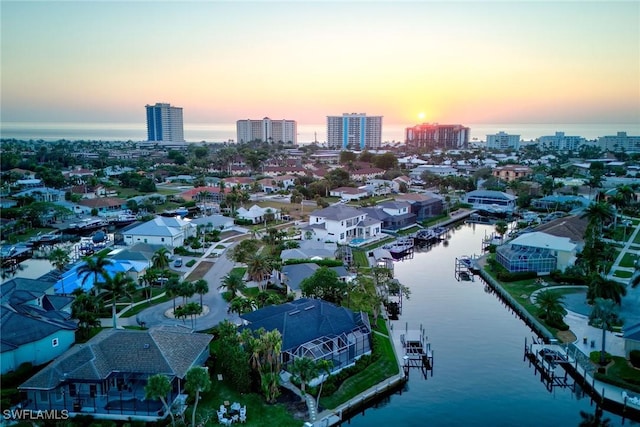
[320,320,400,408]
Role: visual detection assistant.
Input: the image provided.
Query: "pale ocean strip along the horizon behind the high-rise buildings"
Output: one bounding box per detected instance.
[0,122,640,144]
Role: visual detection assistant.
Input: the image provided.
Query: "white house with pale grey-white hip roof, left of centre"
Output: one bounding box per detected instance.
[123,216,196,248]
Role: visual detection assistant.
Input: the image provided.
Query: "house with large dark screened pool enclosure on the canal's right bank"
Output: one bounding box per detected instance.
[496,231,578,274]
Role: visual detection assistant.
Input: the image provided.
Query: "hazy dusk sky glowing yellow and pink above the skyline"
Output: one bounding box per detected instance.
[0,0,640,124]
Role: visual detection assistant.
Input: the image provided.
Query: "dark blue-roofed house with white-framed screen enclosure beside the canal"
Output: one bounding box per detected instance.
[240,298,371,373]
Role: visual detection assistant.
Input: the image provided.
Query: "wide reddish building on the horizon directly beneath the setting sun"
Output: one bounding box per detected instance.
[405,123,469,150]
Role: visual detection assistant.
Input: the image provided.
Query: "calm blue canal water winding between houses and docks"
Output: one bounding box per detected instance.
[348,224,640,427]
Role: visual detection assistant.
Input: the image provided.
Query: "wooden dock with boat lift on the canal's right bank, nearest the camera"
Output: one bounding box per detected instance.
[524,338,576,392]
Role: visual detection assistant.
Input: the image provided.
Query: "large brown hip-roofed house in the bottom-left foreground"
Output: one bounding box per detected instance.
[19,327,213,422]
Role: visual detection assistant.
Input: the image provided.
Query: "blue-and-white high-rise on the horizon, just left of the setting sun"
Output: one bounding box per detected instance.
[327,113,382,150]
